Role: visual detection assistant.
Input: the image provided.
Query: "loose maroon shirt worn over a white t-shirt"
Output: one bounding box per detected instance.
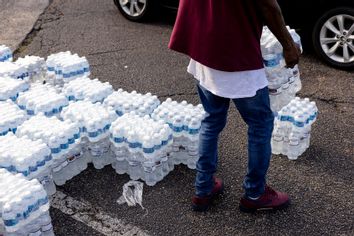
[168,0,263,72]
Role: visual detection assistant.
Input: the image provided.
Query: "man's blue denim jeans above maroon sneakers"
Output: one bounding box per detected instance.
[195,85,274,197]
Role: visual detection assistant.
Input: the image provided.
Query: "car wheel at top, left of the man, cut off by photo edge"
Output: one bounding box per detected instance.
[113,0,156,22]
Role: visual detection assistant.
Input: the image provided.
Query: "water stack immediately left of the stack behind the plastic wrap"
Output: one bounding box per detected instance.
[61,101,117,169]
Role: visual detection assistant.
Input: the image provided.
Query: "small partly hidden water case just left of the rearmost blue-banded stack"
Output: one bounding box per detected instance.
[15,56,47,82]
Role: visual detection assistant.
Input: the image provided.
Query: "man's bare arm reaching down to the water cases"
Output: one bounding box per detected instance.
[254,0,300,68]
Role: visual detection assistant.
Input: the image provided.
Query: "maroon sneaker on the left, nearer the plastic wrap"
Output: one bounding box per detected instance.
[192,177,224,211]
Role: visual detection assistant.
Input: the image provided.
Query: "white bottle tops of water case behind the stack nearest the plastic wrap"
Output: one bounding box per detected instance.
[103,89,160,117]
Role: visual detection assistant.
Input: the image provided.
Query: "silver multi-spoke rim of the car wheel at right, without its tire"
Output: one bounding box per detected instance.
[320,14,354,64]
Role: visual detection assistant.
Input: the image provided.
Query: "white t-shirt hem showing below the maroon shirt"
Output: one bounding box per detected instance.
[187,59,268,99]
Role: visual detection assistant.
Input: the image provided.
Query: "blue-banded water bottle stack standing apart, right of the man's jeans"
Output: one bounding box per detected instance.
[272,97,318,160]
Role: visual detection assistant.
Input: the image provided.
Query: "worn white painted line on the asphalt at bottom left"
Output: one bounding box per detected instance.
[51,191,148,236]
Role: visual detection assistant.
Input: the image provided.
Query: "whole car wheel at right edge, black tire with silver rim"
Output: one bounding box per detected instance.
[312,7,354,70]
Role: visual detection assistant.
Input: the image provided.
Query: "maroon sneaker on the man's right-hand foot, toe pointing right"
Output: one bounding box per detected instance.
[240,186,290,212]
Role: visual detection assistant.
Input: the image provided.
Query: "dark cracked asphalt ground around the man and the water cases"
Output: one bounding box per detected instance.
[6,0,354,235]
